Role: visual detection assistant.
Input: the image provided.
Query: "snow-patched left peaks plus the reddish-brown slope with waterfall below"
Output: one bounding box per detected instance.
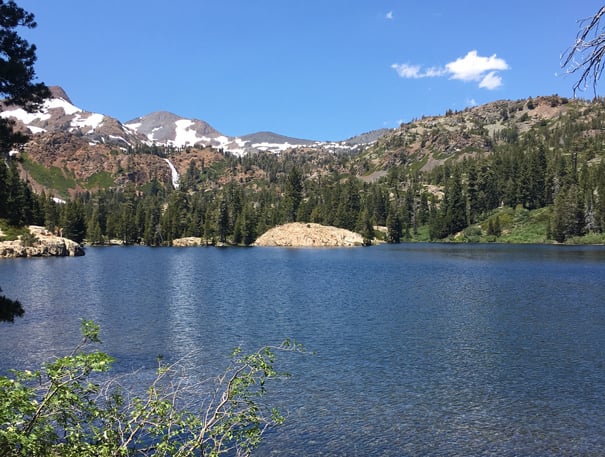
[0,86,386,199]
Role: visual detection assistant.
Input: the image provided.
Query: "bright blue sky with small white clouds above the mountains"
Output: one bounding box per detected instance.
[17,0,602,140]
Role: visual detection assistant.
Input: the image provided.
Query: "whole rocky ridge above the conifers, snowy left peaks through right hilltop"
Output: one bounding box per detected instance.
[0,87,600,199]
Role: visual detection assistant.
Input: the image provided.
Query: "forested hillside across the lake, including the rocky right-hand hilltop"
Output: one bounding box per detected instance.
[0,96,605,246]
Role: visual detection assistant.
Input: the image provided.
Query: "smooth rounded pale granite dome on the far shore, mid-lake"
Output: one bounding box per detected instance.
[254,222,363,247]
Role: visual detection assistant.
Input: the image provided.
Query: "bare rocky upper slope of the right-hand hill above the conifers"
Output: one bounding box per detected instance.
[356,95,589,176]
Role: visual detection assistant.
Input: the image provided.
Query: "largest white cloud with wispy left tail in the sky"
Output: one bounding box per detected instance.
[391,50,510,90]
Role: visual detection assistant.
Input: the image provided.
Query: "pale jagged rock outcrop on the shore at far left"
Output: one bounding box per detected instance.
[0,225,84,258]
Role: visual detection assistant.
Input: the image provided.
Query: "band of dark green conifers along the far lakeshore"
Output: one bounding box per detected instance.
[0,96,605,246]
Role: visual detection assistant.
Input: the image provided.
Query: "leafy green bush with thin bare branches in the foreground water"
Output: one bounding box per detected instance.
[0,321,303,457]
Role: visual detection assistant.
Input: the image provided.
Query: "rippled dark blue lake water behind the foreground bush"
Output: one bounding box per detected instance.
[0,244,605,456]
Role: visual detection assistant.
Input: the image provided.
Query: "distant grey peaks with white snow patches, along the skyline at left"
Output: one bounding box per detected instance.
[0,86,386,156]
